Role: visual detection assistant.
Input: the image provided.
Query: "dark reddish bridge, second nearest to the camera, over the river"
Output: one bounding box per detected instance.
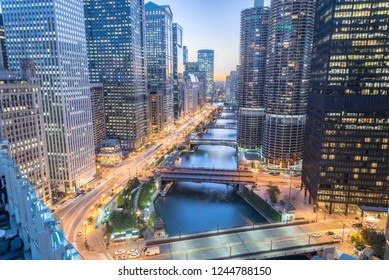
[155,167,255,185]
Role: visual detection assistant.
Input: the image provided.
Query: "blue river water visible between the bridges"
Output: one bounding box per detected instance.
[154,110,266,235]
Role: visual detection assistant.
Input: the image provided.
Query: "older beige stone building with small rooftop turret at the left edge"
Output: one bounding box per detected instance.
[0,59,51,205]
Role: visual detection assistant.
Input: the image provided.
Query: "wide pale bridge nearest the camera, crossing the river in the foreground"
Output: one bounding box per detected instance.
[142,220,347,260]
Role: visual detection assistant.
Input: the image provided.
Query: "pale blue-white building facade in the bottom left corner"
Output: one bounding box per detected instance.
[0,140,80,260]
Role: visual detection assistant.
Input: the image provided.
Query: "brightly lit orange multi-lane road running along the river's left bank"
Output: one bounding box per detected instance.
[54,105,217,260]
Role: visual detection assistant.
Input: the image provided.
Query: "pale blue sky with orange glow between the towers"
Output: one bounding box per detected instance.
[151,0,270,81]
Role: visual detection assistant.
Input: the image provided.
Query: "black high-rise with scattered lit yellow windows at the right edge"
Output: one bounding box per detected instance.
[302,0,389,214]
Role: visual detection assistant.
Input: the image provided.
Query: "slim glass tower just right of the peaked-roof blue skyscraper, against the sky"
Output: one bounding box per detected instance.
[173,23,184,120]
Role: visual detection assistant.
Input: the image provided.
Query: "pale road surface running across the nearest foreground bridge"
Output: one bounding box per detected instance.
[141,221,351,260]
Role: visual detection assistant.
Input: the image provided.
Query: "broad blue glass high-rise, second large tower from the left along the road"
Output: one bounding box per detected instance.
[85,0,149,150]
